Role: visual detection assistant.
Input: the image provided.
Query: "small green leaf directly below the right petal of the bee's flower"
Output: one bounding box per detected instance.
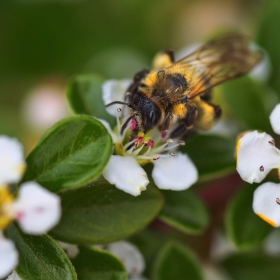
[160,190,209,234]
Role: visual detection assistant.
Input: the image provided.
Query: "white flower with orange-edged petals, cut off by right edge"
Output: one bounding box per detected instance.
[237,104,280,227]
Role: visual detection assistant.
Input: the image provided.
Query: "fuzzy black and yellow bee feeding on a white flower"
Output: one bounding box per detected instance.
[106,33,262,138]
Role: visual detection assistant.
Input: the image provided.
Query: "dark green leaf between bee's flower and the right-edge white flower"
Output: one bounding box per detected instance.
[181,135,235,181]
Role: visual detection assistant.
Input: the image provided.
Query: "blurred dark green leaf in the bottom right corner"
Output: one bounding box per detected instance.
[220,254,280,280]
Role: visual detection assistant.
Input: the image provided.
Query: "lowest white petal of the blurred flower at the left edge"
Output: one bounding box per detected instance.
[0,234,18,278]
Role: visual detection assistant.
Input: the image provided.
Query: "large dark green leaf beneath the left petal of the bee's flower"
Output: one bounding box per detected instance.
[51,181,163,244]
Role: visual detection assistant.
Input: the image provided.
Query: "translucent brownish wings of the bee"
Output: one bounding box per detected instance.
[170,33,262,99]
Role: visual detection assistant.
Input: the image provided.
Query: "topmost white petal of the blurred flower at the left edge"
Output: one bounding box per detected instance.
[0,135,25,185]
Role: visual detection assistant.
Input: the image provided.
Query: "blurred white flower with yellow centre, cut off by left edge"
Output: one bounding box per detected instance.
[0,136,61,279]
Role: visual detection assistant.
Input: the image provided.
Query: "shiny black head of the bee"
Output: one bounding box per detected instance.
[129,91,161,133]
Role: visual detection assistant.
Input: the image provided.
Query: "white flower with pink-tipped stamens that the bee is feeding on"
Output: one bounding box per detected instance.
[100,80,198,196]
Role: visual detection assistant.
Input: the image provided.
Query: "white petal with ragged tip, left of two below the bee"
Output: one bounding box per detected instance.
[103,156,149,196]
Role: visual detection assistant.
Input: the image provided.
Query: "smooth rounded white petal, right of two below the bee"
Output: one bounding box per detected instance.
[152,153,198,191]
